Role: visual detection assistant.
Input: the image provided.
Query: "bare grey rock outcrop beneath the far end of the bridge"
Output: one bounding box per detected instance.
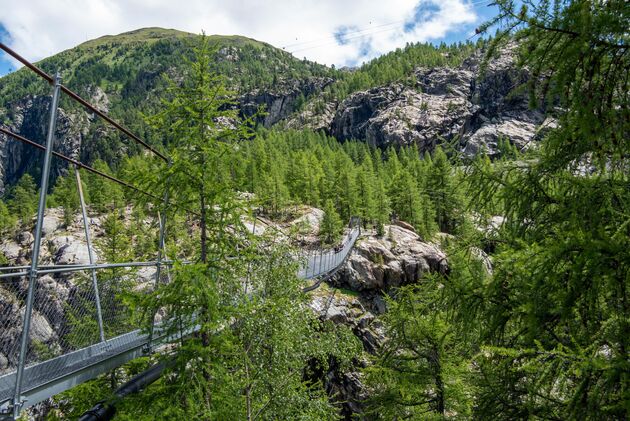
[310,221,449,419]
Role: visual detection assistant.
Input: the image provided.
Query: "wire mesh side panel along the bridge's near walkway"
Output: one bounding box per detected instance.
[0,262,171,402]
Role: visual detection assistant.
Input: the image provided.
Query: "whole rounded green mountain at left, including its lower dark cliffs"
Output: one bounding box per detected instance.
[0,28,339,184]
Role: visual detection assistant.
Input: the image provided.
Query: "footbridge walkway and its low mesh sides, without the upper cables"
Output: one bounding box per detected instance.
[0,228,360,420]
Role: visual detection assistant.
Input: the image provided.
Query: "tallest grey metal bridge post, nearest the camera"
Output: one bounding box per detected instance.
[13,73,61,418]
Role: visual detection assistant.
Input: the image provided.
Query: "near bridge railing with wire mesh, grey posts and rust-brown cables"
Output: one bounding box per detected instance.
[0,43,173,418]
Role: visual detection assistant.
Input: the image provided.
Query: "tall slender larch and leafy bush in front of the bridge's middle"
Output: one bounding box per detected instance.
[94,38,358,420]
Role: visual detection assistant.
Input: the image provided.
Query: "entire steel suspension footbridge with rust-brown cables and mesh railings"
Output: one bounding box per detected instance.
[0,43,360,420]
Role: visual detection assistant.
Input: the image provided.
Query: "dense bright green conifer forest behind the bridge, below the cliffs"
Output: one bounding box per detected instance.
[0,130,472,248]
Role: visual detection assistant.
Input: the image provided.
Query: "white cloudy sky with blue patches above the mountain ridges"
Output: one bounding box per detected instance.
[0,0,494,75]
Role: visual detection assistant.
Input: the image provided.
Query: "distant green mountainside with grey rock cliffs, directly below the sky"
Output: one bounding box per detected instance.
[0,24,549,191]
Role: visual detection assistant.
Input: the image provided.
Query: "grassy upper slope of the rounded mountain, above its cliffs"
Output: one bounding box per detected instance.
[0,28,337,110]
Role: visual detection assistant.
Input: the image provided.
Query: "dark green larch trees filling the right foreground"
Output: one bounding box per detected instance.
[367,0,630,420]
